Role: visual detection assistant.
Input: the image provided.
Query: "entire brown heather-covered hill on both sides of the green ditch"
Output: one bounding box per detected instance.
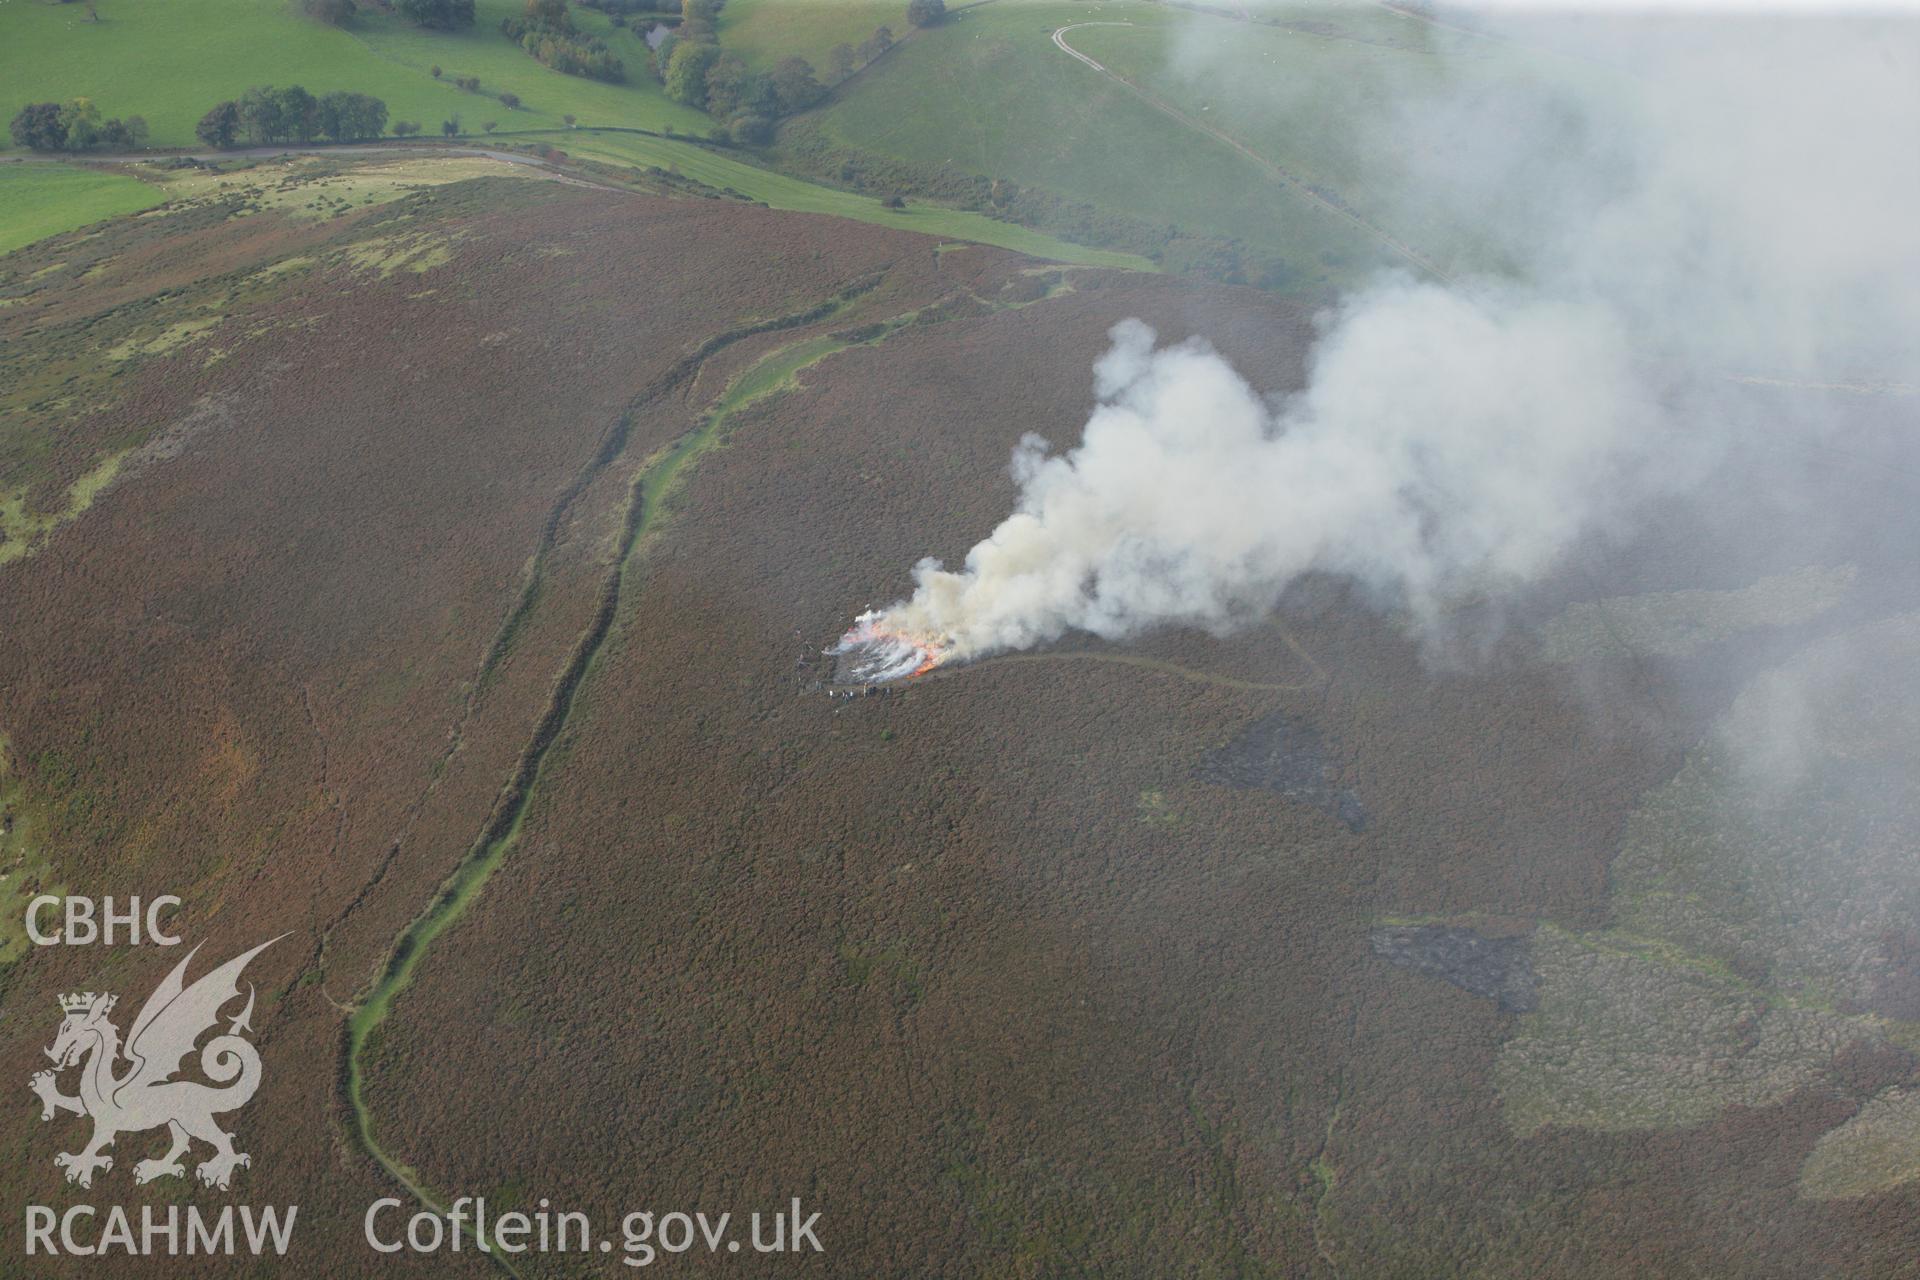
[0,165,1920,1278]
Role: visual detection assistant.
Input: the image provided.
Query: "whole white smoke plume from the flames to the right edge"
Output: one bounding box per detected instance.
[851,19,1920,674]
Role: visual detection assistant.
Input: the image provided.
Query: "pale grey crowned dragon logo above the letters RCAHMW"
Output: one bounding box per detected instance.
[29,935,286,1192]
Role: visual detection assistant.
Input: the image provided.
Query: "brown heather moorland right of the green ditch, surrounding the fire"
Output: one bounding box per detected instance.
[353,253,1914,1276]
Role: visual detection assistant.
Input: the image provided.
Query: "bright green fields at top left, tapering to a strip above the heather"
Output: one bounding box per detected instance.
[0,0,1152,269]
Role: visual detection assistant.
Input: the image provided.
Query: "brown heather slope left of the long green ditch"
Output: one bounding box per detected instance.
[0,167,983,1274]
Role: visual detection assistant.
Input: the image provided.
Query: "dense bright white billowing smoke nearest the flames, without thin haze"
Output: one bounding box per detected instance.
[875,297,1649,656]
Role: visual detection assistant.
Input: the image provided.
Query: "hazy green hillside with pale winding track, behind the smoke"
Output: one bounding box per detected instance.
[771,0,1597,284]
